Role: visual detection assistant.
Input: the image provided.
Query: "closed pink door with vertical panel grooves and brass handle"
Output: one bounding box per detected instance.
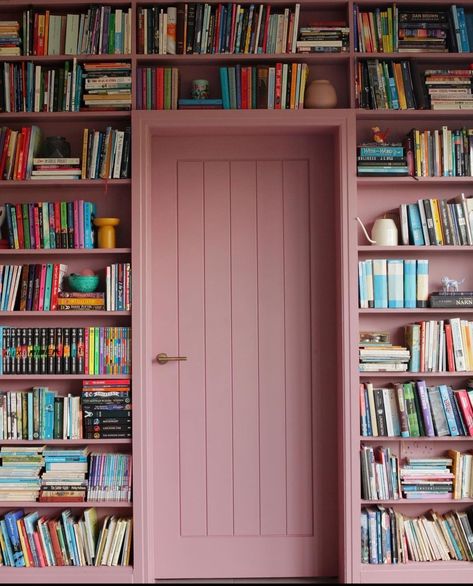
[149,136,337,578]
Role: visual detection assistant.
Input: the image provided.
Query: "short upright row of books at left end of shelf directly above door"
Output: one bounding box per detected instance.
[136,67,179,110]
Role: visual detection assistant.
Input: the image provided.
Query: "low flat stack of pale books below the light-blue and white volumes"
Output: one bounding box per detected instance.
[358,334,411,372]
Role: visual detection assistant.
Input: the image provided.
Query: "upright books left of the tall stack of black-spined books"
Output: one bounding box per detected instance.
[0,388,82,440]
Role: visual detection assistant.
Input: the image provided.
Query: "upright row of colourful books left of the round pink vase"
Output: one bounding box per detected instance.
[220,63,309,110]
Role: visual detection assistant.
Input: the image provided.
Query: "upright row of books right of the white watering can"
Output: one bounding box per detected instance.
[399,193,473,246]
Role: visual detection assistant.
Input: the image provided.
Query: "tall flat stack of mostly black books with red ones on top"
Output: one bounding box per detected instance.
[81,379,132,439]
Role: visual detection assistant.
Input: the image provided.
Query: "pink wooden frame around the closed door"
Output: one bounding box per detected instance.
[131,110,352,583]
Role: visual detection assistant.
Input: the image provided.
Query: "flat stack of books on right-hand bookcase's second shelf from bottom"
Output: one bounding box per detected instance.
[399,457,455,500]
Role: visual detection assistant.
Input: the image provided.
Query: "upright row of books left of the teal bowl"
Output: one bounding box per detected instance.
[0,263,67,311]
